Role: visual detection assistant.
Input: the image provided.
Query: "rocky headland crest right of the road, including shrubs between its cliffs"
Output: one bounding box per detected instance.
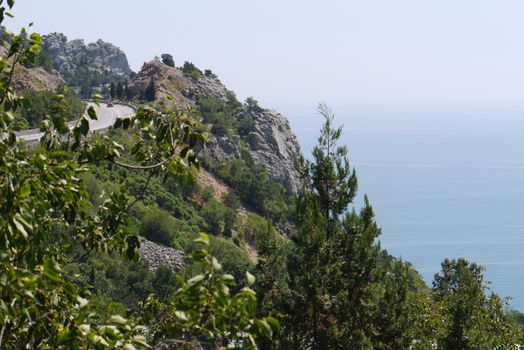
[129,61,300,191]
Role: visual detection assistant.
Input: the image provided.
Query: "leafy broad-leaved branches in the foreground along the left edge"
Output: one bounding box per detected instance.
[0,1,204,348]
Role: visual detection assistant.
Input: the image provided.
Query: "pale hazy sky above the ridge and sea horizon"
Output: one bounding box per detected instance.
[6,0,524,109]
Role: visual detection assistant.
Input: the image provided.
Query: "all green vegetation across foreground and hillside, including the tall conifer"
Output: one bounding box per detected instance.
[0,1,524,350]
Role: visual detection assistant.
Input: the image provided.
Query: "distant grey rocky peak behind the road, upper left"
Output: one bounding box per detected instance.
[42,33,131,80]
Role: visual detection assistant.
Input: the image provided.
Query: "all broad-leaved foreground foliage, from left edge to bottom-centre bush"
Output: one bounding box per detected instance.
[0,1,278,349]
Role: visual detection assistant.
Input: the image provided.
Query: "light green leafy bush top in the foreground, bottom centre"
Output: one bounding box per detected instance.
[145,234,279,349]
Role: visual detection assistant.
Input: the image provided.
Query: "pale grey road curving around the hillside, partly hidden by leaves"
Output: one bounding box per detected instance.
[16,102,135,143]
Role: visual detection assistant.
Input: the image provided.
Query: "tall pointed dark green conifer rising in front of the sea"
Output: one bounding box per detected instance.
[279,104,420,350]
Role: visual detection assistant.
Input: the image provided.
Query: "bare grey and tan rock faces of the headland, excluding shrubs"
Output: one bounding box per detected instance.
[130,61,300,191]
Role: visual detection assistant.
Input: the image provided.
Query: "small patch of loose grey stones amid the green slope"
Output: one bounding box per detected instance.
[140,239,187,272]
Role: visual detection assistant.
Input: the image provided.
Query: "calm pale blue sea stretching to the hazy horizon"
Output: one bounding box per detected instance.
[281,107,524,311]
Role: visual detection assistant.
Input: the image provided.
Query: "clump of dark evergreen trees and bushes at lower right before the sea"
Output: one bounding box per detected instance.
[251,105,522,350]
